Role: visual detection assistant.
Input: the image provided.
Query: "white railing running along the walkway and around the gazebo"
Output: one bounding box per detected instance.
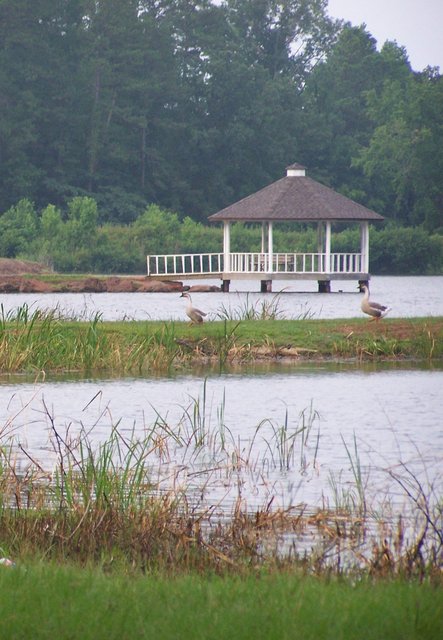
[147,253,363,276]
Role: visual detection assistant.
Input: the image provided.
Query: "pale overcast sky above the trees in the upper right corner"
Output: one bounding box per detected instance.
[328,0,443,73]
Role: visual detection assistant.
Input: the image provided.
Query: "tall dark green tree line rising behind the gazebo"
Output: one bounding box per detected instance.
[0,0,443,262]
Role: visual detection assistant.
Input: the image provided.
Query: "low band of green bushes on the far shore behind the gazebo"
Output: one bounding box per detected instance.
[0,196,443,274]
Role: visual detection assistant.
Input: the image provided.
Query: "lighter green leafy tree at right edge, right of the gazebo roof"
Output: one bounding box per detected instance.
[354,65,443,230]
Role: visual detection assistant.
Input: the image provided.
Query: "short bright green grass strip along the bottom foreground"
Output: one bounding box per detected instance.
[0,563,443,640]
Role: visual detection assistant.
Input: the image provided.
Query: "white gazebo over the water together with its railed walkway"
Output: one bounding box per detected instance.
[147,164,383,292]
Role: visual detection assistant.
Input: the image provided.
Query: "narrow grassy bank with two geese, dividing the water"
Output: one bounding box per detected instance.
[0,307,443,375]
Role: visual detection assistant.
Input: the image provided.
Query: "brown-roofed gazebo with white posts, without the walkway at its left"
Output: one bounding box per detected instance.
[209,163,383,291]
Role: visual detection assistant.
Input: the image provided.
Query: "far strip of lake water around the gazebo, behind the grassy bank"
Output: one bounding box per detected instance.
[0,276,443,320]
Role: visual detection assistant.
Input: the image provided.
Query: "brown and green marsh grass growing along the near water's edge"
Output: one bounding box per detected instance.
[0,388,443,579]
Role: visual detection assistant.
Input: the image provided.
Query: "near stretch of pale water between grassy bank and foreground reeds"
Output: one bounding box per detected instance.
[0,364,443,509]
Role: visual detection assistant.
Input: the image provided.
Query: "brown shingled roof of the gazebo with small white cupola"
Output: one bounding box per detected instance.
[209,164,383,222]
